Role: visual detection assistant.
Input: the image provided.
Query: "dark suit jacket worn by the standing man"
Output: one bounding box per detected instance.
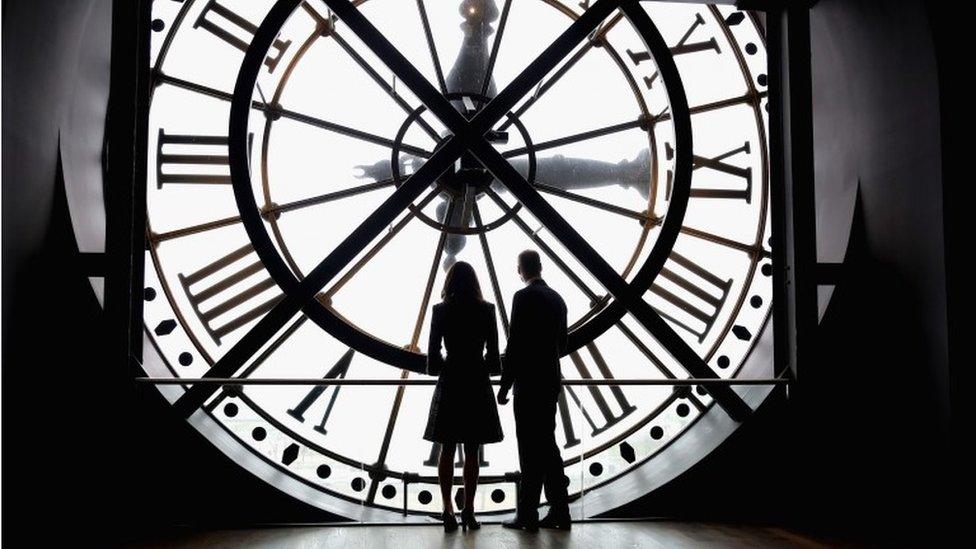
[502,278,567,392]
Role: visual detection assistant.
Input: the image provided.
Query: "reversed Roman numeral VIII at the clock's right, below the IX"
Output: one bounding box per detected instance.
[648,251,732,343]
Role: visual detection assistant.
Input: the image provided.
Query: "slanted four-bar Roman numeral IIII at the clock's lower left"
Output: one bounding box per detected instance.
[179,244,283,345]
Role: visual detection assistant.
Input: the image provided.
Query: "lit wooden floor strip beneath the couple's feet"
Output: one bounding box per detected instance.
[132,521,856,549]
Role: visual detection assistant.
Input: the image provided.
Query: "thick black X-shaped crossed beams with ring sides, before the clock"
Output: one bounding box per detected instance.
[174,0,751,421]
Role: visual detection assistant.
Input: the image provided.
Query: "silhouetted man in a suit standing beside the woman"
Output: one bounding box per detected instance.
[498,250,570,531]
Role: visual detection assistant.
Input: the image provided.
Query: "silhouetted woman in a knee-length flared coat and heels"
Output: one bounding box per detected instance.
[424,261,503,532]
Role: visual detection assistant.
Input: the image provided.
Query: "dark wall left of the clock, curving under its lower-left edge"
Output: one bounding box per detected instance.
[0,0,330,546]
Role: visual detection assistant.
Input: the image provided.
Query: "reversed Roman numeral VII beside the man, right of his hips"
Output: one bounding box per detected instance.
[557,342,637,448]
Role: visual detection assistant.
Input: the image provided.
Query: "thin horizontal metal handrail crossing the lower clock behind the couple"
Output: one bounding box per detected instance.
[135,377,791,386]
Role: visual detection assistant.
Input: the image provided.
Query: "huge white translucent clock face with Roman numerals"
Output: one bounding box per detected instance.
[145,0,772,518]
